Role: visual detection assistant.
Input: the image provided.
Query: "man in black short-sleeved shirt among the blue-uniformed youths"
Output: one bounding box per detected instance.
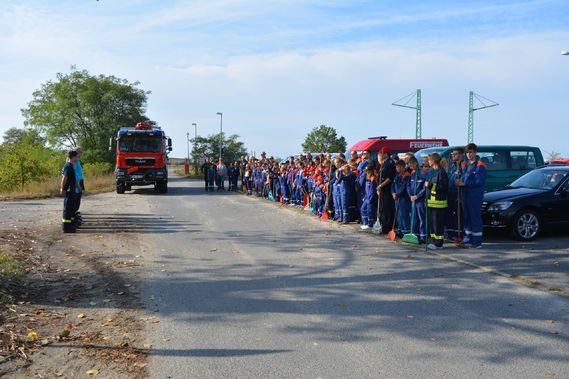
[377,146,396,234]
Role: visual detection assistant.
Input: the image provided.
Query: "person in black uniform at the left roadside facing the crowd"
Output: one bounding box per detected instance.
[59,150,81,233]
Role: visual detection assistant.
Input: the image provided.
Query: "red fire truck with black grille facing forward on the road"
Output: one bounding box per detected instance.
[109,122,172,194]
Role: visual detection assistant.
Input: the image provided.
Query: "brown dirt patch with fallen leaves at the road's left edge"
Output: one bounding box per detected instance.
[0,228,151,378]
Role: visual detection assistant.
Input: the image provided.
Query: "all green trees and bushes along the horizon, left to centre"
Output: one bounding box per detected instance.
[0,66,346,190]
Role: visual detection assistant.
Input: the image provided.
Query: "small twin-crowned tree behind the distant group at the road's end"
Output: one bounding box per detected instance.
[192,133,247,168]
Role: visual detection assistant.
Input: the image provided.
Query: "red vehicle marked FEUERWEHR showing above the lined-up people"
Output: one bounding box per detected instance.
[350,136,448,162]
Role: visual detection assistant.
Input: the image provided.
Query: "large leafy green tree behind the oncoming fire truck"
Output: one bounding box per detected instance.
[22,67,153,161]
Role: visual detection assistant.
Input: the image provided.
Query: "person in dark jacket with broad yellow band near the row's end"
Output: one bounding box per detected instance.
[425,153,448,250]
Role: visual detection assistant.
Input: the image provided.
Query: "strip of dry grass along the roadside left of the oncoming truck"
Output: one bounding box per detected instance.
[0,173,115,200]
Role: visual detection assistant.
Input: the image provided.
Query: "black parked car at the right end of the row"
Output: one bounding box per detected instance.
[482,166,569,241]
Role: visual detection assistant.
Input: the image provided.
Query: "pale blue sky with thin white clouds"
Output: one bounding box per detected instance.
[0,0,569,157]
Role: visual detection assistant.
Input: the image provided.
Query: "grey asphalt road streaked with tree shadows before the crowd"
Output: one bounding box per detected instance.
[4,178,569,378]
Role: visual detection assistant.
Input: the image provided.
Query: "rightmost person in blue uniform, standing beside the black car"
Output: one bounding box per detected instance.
[455,143,488,248]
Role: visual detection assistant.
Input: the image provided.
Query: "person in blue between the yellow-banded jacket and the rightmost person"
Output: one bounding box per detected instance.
[445,147,464,243]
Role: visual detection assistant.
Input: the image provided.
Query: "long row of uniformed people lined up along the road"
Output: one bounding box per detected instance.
[201,143,487,250]
